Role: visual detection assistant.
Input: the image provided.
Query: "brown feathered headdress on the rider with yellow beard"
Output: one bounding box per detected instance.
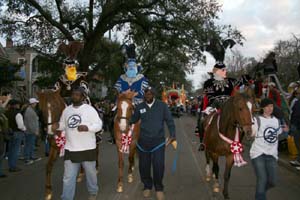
[57,41,83,64]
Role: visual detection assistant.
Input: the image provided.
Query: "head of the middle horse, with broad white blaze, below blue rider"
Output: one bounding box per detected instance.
[116,91,136,132]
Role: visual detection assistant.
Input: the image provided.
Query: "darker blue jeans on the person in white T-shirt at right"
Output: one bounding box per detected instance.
[252,154,277,200]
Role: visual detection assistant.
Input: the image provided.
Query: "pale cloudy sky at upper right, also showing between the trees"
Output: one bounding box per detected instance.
[188,0,300,88]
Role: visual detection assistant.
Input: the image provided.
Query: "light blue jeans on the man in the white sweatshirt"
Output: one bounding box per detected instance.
[61,160,98,200]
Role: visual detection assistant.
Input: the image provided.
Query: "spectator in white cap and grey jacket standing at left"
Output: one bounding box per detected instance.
[24,98,41,165]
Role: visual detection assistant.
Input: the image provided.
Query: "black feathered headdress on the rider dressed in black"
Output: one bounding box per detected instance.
[203,39,236,69]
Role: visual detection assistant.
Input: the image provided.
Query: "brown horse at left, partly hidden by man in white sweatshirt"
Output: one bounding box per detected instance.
[37,90,66,200]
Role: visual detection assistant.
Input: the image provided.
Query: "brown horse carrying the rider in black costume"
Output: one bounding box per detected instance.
[204,93,252,199]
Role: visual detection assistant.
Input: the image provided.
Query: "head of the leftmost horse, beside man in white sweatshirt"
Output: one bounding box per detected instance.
[36,90,66,134]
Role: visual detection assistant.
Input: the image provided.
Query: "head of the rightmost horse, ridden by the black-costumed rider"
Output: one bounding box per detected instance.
[232,93,253,136]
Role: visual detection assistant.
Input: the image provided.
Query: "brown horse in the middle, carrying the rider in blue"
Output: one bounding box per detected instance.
[114,91,140,192]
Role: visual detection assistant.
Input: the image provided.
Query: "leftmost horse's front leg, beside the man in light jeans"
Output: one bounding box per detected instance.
[45,137,59,200]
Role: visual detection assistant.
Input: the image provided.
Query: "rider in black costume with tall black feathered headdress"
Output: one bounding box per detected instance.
[199,39,238,151]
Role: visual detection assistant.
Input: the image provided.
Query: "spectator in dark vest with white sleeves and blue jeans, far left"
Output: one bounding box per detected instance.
[6,99,26,172]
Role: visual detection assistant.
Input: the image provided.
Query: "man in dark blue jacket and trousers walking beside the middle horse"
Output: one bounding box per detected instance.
[131,87,176,200]
